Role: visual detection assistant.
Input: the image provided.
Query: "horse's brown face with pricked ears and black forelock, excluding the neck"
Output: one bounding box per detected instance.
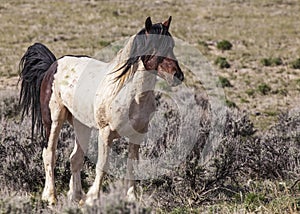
[138,16,184,86]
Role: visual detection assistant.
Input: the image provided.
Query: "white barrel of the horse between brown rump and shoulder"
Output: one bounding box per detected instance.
[53,56,107,127]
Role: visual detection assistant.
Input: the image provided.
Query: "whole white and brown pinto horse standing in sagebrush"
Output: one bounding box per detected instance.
[19,16,184,205]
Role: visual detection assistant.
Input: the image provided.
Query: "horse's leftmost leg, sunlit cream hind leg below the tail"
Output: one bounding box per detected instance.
[42,99,67,204]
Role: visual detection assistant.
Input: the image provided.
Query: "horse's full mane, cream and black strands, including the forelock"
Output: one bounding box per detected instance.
[114,23,174,88]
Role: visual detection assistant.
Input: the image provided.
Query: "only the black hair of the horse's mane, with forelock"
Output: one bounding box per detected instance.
[116,23,174,80]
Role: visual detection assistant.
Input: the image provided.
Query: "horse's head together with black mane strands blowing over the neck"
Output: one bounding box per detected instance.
[117,16,184,86]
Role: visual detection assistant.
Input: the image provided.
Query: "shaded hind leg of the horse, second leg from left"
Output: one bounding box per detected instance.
[68,120,91,202]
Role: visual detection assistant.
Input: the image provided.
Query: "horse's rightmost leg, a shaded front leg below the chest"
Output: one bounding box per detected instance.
[126,138,142,201]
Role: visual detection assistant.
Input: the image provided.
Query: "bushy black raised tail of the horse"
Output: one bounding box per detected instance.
[19,43,56,139]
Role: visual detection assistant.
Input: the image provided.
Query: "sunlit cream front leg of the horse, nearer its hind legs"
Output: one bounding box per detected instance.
[85,126,117,205]
